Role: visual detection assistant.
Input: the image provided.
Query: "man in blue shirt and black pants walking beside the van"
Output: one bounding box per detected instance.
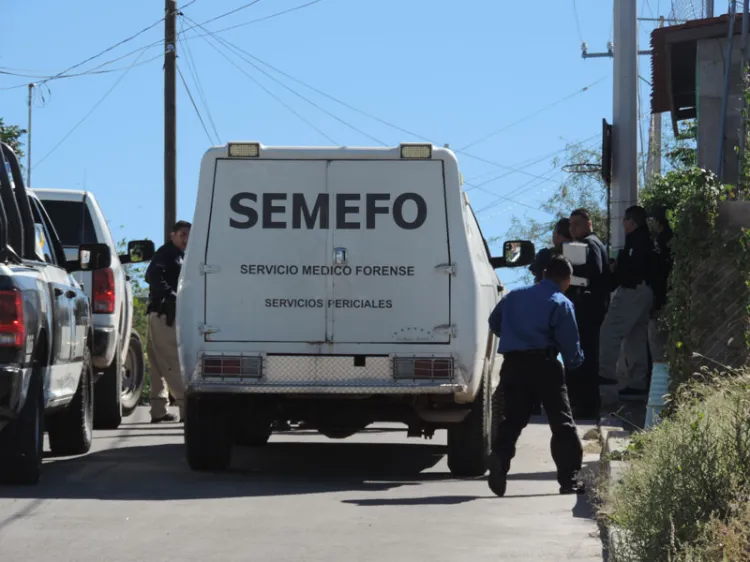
[489,255,584,496]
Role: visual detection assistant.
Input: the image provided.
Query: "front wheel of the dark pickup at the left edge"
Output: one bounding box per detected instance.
[46,347,94,456]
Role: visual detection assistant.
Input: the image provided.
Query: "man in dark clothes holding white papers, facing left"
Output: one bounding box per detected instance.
[567,209,611,420]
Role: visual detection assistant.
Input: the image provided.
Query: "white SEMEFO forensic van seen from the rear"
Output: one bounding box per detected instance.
[177,143,534,477]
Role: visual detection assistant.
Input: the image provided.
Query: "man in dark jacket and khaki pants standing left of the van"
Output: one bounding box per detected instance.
[146,221,191,423]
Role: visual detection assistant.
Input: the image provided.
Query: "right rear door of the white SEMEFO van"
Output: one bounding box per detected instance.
[328,160,450,344]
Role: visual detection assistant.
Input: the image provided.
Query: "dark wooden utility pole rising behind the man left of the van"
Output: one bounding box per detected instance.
[164,0,177,242]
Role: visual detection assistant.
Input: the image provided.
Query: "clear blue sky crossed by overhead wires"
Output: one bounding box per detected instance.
[0,0,668,286]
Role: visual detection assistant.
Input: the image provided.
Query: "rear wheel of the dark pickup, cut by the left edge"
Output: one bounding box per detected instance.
[0,360,44,486]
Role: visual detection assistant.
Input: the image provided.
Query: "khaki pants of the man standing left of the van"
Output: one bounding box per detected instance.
[147,312,185,418]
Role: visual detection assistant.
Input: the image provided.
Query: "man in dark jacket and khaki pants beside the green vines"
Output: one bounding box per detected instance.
[599,205,654,399]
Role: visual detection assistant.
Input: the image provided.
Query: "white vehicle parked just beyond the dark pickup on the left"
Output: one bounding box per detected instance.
[33,189,154,429]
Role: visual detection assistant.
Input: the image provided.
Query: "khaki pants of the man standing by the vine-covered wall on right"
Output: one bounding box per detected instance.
[599,283,654,389]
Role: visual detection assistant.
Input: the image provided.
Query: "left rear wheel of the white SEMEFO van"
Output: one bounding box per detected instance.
[185,396,232,471]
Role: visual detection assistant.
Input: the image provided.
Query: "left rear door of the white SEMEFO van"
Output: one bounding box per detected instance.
[204,158,330,343]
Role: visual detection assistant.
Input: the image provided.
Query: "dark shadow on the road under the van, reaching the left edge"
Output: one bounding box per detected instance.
[0,442,451,501]
